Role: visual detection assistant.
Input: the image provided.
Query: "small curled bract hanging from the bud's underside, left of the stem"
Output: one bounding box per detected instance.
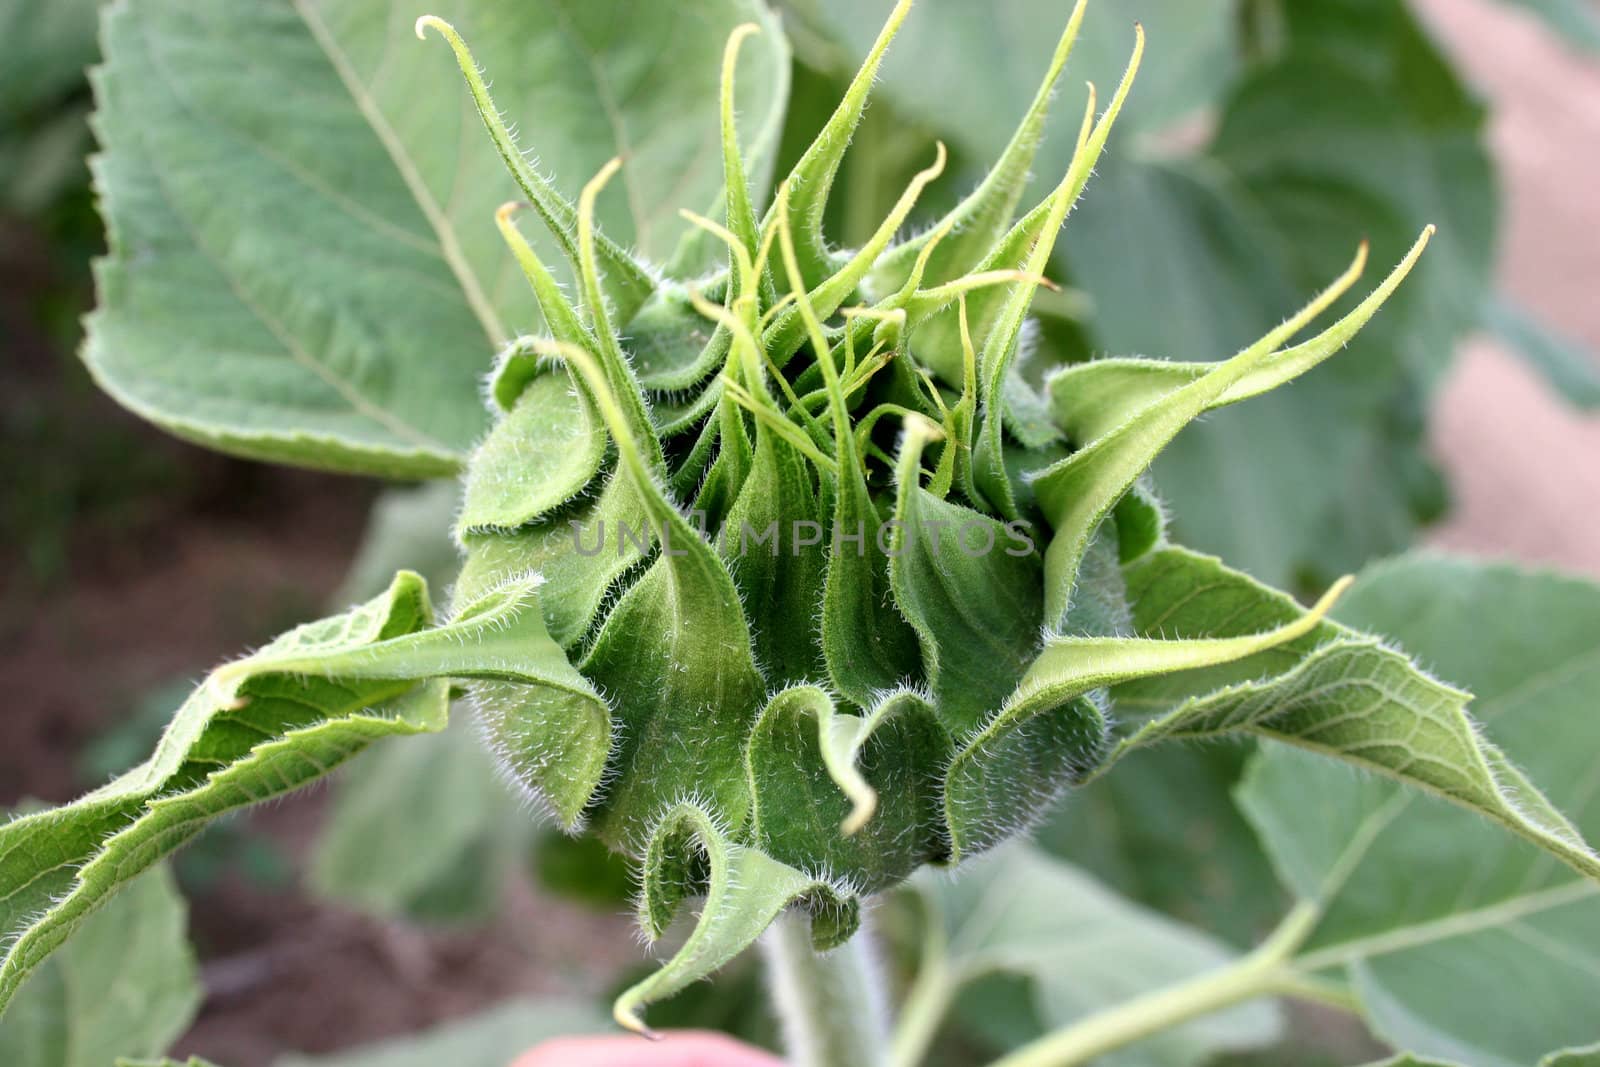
[611,803,859,1033]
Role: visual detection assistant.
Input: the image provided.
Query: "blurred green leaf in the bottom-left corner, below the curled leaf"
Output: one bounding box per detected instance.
[0,867,200,1067]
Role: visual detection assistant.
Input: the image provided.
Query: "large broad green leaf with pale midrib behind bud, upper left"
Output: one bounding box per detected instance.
[85,0,787,475]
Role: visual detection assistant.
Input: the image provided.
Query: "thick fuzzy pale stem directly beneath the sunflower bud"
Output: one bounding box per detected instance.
[762,910,888,1067]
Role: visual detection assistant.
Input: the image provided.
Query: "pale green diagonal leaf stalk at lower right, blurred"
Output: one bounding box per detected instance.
[990,904,1320,1067]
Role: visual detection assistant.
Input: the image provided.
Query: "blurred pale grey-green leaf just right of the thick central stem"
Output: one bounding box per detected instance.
[914,845,1282,1067]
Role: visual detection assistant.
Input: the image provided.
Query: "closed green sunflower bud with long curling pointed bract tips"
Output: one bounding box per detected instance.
[426,0,1465,1029]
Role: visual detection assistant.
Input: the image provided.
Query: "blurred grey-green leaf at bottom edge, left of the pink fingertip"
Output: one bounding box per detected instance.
[274,998,606,1067]
